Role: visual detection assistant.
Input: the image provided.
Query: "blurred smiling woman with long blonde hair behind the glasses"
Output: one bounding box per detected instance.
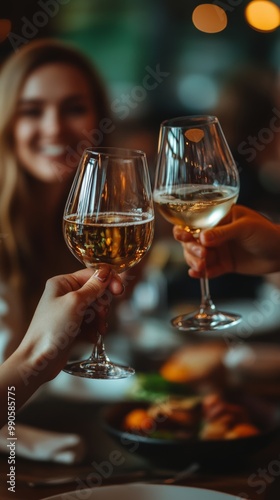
[0,39,114,357]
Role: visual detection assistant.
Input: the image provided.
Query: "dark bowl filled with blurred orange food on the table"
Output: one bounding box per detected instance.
[102,391,279,465]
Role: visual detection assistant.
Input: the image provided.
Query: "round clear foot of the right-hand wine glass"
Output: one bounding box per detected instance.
[171,310,242,332]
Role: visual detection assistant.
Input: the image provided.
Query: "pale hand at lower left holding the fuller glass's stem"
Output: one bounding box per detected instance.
[18,265,124,383]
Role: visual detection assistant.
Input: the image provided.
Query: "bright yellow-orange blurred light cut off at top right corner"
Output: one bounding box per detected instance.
[245,0,280,32]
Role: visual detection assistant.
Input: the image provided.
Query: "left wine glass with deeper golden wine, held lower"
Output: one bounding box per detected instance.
[63,148,154,379]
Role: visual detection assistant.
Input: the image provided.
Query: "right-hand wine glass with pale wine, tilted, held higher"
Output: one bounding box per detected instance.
[153,116,241,331]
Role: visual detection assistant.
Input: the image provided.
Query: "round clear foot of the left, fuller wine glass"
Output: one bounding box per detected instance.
[63,359,135,380]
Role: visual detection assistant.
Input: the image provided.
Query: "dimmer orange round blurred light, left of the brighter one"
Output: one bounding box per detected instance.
[192,3,227,33]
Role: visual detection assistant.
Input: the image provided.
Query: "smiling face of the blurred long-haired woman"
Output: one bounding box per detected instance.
[14,63,98,183]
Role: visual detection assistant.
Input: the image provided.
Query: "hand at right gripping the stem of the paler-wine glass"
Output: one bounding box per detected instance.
[173,205,280,278]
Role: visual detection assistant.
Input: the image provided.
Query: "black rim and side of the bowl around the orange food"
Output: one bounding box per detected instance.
[102,394,280,467]
